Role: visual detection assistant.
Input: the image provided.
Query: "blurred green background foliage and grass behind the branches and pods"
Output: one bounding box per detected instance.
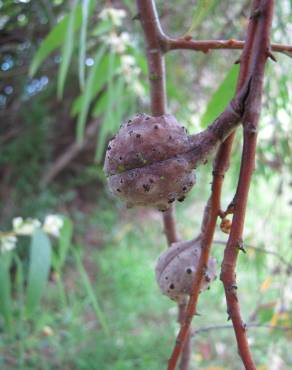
[0,0,292,370]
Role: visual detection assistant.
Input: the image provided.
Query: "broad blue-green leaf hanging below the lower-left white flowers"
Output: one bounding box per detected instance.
[26,229,51,316]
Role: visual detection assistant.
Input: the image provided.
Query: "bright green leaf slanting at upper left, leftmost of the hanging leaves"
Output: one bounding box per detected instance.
[29,0,95,77]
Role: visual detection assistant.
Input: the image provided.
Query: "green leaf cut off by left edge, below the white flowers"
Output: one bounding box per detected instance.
[0,252,12,331]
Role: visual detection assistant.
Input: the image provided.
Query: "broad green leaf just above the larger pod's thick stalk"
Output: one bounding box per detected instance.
[201,64,239,128]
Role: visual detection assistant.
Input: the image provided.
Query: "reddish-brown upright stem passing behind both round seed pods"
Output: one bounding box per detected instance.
[137,0,190,370]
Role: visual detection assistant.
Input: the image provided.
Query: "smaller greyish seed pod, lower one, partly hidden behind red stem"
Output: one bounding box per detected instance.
[155,238,216,303]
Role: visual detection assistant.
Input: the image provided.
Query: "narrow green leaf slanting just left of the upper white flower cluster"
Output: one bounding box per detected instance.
[77,45,106,143]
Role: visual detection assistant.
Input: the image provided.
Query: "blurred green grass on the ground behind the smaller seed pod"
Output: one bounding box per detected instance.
[0,177,292,370]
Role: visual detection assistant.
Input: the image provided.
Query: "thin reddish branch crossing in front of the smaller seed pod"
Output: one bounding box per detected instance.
[168,0,259,370]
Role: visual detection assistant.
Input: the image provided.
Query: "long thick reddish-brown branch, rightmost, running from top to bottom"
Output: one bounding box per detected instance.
[220,0,274,369]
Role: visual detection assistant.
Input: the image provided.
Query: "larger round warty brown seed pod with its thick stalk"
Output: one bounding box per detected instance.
[104,97,244,211]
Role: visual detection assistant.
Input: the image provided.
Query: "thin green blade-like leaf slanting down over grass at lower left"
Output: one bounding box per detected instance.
[74,250,109,336]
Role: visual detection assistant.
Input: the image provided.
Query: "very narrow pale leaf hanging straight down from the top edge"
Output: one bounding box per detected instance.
[79,0,89,90]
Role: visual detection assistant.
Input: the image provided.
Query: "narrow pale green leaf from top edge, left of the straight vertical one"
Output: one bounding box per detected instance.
[57,0,78,99]
